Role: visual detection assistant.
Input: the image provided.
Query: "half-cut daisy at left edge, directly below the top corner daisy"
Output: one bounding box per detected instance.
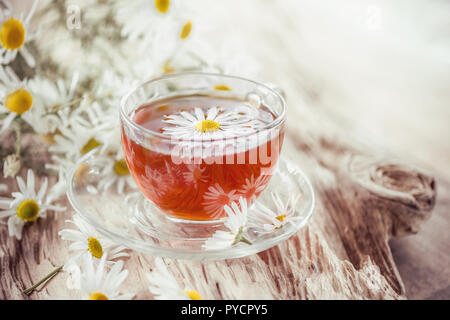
[0,66,34,134]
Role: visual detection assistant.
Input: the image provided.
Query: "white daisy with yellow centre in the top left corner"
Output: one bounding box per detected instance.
[0,0,39,67]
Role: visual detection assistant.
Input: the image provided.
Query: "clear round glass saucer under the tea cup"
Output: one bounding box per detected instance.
[67,150,314,260]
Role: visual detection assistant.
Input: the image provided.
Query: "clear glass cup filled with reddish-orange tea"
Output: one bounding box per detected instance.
[120,73,286,222]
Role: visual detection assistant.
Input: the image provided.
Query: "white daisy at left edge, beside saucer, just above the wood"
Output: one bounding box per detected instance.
[0,169,66,240]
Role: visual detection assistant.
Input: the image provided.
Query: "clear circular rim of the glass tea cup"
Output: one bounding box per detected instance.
[120,72,286,142]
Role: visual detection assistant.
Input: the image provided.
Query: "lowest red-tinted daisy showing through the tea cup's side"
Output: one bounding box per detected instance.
[202,183,239,218]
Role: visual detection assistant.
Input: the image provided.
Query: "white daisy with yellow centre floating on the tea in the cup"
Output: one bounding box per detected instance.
[162,107,255,141]
